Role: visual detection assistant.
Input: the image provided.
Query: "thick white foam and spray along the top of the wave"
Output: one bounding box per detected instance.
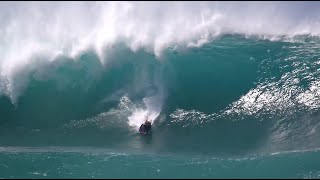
[0,2,320,102]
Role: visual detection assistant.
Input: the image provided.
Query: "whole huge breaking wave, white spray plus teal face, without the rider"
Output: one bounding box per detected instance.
[0,2,320,177]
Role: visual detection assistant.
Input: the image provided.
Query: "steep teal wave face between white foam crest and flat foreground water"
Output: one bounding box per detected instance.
[1,35,320,153]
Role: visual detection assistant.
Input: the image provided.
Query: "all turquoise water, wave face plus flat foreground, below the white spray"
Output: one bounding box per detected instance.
[0,36,320,178]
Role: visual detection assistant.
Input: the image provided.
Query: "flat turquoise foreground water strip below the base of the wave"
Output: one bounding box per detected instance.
[0,147,320,178]
